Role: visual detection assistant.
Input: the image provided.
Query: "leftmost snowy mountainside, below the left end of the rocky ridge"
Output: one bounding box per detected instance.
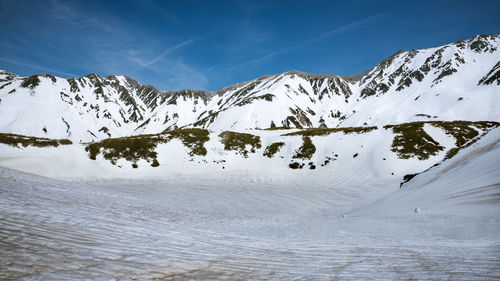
[0,71,213,141]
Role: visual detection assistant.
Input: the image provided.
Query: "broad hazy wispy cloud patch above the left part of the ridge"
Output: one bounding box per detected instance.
[45,0,208,90]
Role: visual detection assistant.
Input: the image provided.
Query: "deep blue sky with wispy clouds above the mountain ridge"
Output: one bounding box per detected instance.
[0,0,500,90]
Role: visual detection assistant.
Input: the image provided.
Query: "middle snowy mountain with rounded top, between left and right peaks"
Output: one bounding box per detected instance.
[176,71,353,130]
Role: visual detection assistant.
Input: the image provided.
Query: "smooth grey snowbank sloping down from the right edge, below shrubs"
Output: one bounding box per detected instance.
[351,126,500,218]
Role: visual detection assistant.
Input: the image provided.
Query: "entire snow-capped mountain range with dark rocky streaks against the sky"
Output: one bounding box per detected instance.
[0,35,500,141]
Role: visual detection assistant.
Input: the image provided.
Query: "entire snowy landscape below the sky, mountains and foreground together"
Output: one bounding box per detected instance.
[0,34,500,280]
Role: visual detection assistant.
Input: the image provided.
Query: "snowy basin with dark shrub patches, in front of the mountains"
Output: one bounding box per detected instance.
[0,122,500,280]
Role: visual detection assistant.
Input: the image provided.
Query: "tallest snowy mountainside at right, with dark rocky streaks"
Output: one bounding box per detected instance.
[343,32,500,126]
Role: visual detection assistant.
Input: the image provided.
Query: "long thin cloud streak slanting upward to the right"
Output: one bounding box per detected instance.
[227,14,385,72]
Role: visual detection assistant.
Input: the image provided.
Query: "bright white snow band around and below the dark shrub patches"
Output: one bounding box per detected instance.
[0,125,472,179]
